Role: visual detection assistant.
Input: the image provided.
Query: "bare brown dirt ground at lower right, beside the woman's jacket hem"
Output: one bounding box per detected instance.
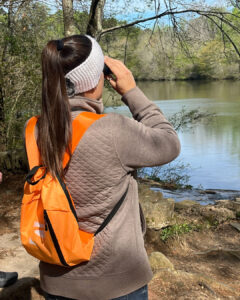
[147,223,240,300]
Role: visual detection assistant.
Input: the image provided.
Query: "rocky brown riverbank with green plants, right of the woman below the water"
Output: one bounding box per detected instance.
[140,186,240,300]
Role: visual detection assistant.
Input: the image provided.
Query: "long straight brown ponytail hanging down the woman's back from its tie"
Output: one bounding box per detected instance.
[38,41,72,177]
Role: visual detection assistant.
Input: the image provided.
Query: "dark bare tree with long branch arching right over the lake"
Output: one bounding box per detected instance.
[63,0,240,57]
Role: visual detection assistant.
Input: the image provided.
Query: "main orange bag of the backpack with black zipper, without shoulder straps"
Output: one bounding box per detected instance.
[21,174,94,266]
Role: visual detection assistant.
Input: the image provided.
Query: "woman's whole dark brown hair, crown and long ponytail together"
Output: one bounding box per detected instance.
[38,35,92,177]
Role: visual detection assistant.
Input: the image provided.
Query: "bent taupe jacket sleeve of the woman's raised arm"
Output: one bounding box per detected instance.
[112,87,180,172]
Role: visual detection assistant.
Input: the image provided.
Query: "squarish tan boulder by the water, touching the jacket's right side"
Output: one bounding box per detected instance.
[139,187,174,230]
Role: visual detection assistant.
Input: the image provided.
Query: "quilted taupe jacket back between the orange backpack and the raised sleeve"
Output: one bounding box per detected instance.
[66,115,126,232]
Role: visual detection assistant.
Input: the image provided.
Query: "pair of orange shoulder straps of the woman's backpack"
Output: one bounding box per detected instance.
[25,111,105,170]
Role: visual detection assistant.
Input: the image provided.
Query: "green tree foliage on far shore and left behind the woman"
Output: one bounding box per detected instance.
[0,0,240,151]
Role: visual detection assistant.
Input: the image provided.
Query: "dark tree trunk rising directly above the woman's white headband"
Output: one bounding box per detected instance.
[87,0,106,40]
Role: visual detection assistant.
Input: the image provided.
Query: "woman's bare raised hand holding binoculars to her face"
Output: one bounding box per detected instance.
[104,56,136,95]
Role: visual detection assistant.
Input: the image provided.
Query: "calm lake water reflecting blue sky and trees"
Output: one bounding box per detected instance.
[106,81,240,190]
